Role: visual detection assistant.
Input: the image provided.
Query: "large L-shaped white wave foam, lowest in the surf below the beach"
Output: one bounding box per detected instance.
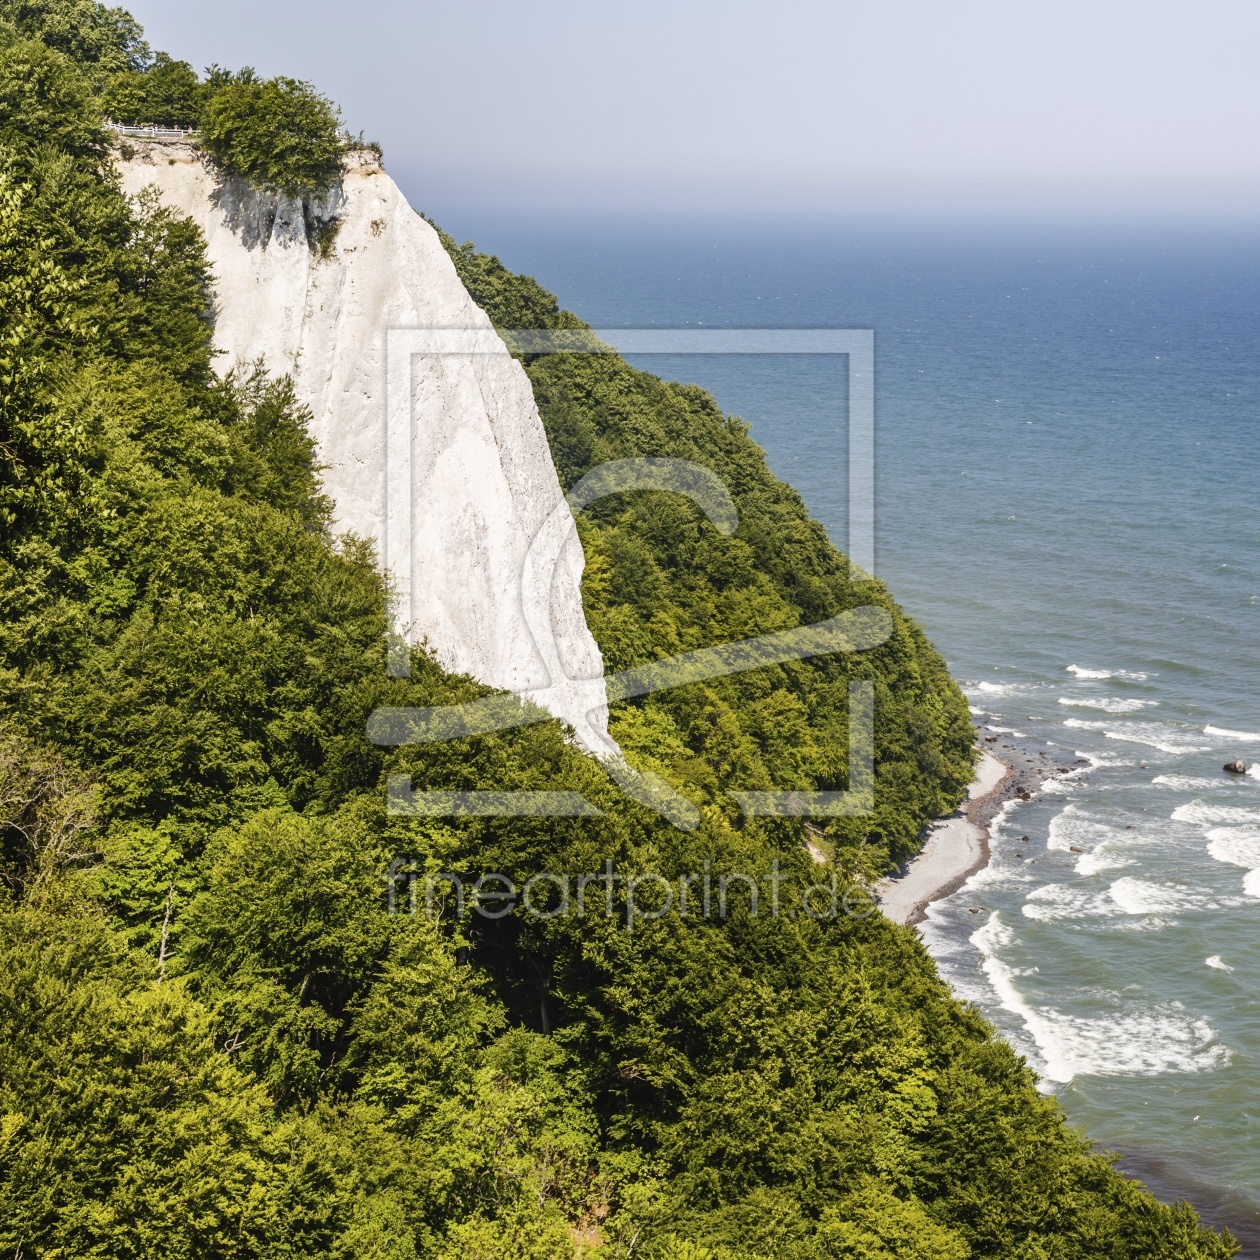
[971,912,1230,1084]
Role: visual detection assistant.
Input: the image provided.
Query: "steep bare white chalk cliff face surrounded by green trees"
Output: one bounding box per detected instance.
[120,142,616,755]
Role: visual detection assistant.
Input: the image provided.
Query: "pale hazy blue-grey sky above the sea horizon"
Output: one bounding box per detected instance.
[120,0,1260,215]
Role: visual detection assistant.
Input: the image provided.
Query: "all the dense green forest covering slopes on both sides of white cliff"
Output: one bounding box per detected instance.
[0,0,1234,1260]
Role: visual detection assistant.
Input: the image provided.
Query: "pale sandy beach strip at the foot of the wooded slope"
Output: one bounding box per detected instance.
[876,750,1016,925]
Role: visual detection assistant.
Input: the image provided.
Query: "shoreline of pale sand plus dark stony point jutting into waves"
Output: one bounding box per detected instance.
[876,728,1079,927]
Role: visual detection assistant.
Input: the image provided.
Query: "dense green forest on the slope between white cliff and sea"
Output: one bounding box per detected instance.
[445,237,974,876]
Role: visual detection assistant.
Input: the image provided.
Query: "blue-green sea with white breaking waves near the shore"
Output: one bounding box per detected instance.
[423,207,1260,1256]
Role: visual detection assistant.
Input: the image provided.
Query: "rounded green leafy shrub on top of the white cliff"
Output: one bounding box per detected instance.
[202,69,344,197]
